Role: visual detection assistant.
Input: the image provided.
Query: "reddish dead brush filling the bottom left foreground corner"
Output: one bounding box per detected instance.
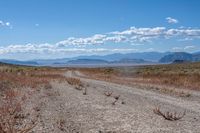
[0,89,36,133]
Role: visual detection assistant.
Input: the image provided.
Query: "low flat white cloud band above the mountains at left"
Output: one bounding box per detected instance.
[0,44,137,54]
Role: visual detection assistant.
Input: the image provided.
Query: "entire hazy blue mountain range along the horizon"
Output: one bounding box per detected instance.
[0,52,200,66]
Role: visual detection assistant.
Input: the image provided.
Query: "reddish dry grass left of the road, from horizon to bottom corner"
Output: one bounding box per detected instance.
[0,64,67,133]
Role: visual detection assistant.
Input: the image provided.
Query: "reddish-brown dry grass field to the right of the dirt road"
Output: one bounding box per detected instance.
[79,63,200,93]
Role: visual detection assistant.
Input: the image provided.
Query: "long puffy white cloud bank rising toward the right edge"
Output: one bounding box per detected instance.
[56,27,200,47]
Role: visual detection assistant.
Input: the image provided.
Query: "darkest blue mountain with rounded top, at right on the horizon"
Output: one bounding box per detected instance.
[159,52,194,63]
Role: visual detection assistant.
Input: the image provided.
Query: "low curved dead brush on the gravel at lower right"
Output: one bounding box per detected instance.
[153,107,185,121]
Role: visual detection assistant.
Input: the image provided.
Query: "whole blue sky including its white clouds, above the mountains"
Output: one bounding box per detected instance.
[0,0,200,60]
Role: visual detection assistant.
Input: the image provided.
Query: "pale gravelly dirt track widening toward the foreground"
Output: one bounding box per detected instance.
[30,71,200,133]
